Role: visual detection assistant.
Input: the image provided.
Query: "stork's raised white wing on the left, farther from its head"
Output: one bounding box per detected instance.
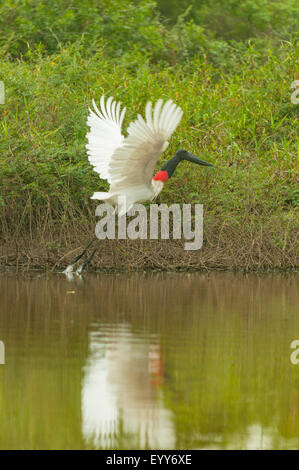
[86,95,126,183]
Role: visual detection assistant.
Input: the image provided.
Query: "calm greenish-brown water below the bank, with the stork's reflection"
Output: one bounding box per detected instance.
[0,273,299,449]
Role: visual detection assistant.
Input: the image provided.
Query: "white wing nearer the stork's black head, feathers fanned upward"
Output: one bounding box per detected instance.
[108,100,183,192]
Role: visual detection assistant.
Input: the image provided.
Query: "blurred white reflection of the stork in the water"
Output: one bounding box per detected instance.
[82,325,175,449]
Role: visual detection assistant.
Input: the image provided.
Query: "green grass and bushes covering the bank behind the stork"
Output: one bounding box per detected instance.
[0,0,299,269]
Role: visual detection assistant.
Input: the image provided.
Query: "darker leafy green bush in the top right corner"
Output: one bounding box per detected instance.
[157,0,299,40]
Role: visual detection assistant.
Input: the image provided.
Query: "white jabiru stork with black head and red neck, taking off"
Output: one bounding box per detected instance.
[64,95,213,274]
